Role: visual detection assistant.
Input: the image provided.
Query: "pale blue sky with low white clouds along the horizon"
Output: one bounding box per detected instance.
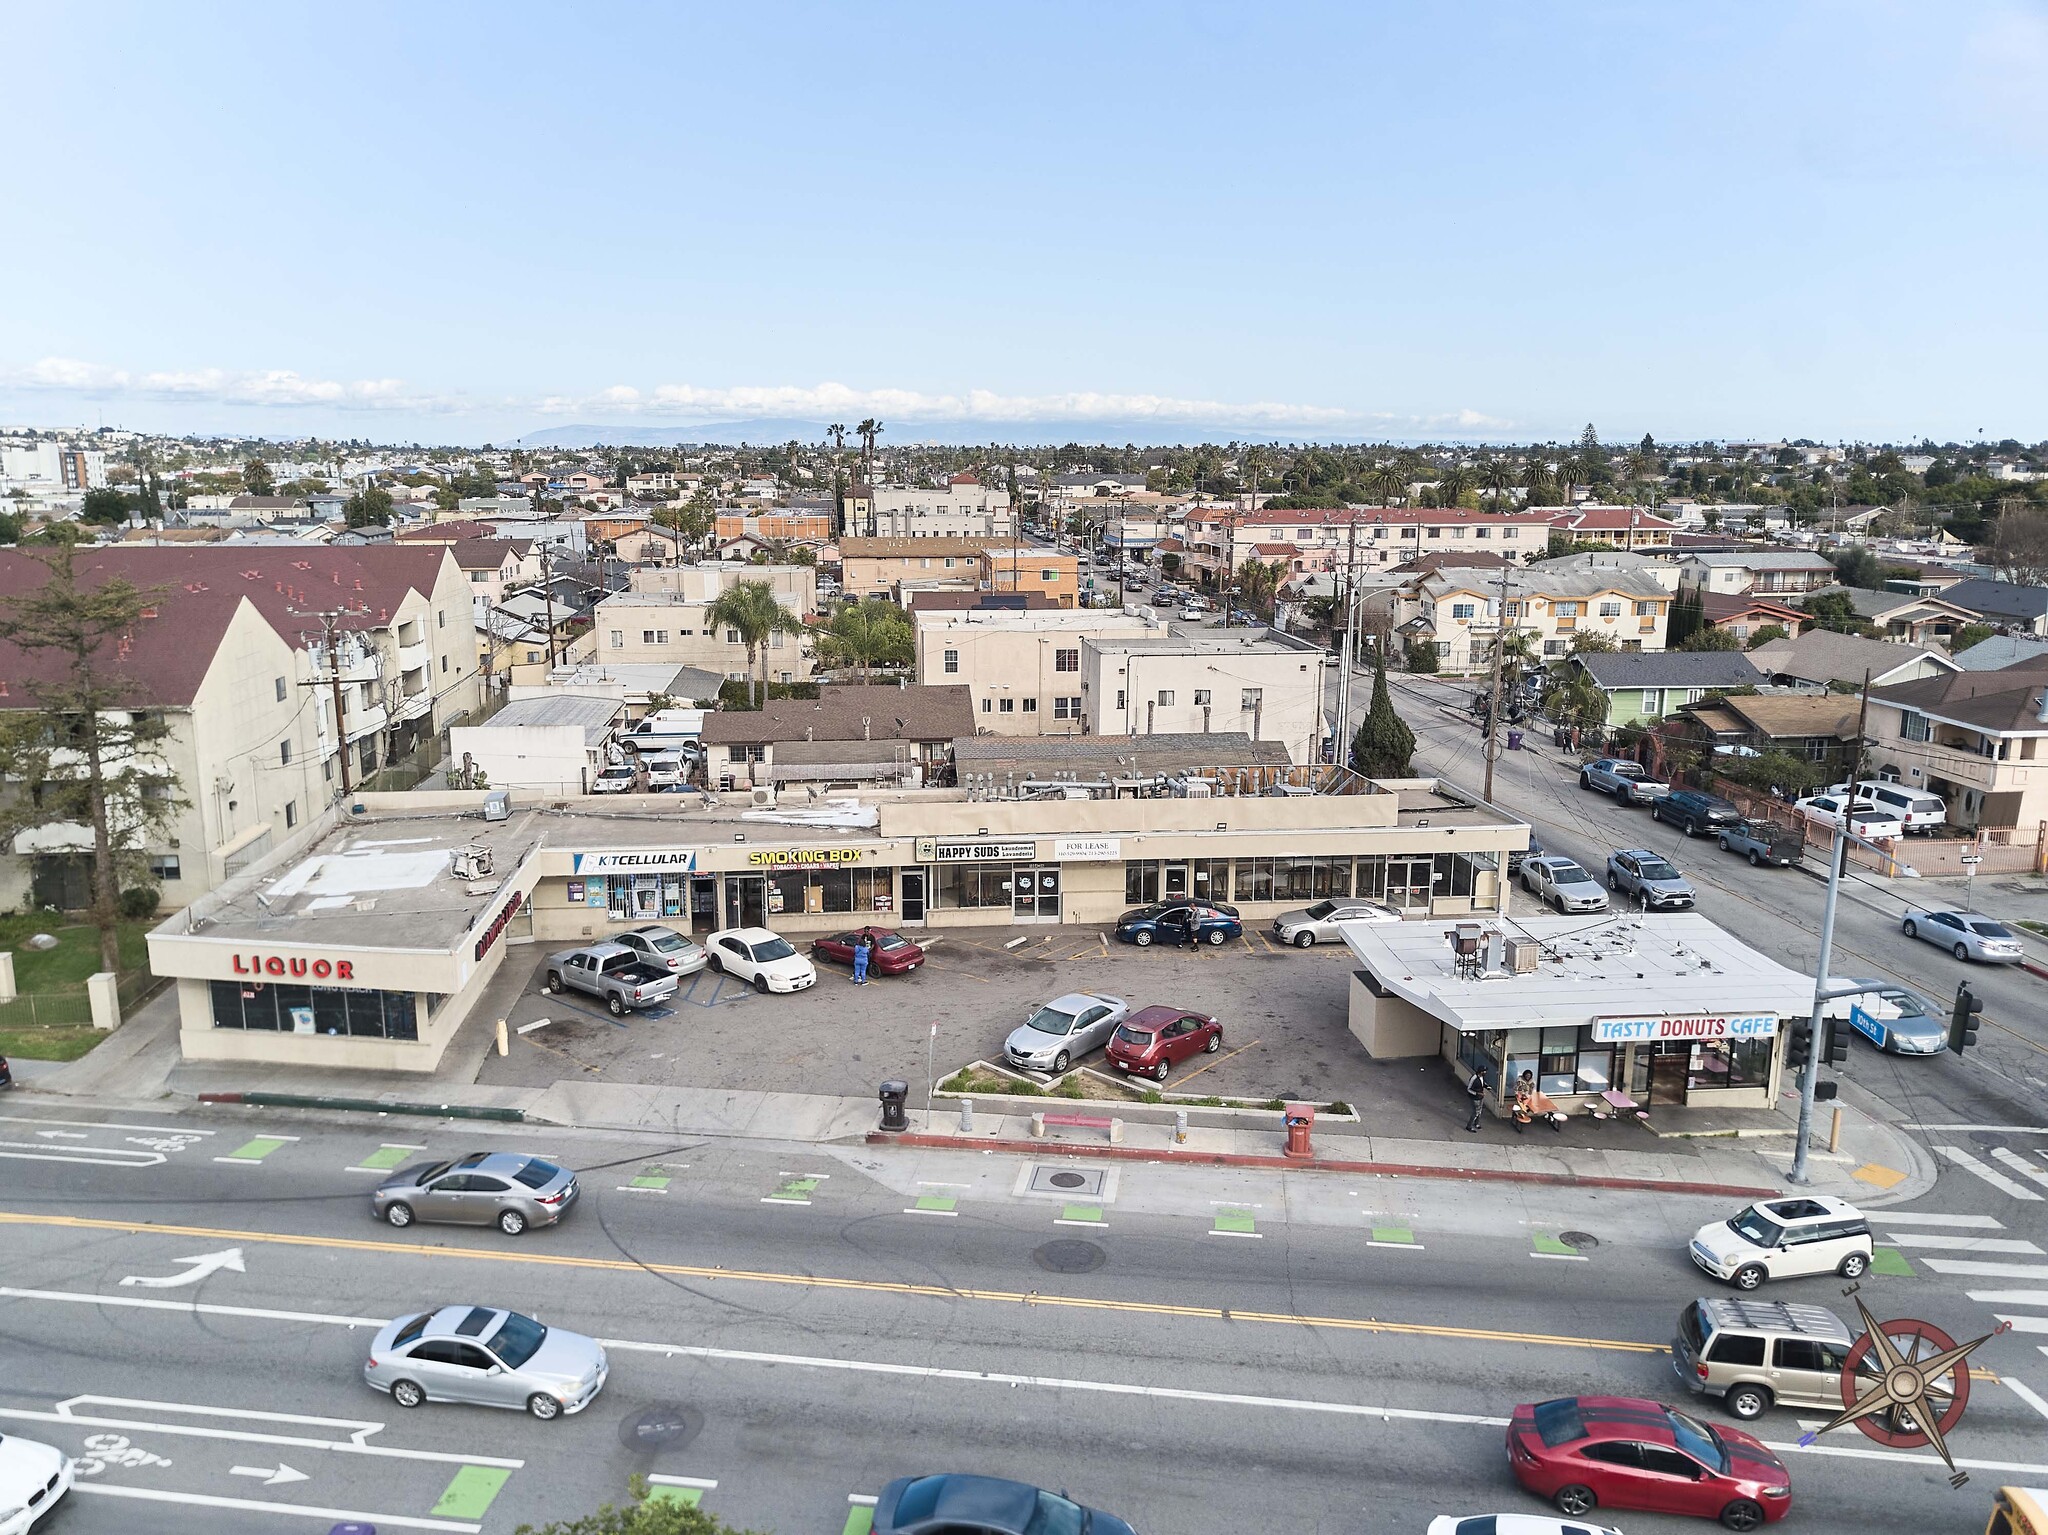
[0,0,2048,444]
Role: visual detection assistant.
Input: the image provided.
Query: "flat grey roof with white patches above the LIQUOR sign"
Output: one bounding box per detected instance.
[158,810,543,950]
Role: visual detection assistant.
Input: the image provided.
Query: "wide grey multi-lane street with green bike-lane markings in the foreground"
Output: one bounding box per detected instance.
[0,1095,2048,1535]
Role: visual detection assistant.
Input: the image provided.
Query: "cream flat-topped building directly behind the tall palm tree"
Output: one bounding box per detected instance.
[588,561,817,682]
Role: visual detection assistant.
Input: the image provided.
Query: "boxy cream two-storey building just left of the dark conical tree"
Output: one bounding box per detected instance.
[1089,624,1333,763]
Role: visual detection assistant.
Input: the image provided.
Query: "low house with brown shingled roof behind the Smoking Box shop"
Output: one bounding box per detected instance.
[700,686,975,788]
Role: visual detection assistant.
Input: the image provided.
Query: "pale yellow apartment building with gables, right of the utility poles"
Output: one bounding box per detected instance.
[1386,567,1671,673]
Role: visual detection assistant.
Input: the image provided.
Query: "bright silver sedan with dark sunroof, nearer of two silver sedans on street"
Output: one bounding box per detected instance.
[362,1306,610,1418]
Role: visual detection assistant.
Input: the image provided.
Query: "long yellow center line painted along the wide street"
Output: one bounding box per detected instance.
[0,1211,1671,1353]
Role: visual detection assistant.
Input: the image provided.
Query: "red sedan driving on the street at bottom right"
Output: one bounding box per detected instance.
[1507,1396,1792,1529]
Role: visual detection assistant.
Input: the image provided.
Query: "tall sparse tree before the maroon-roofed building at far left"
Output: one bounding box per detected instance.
[0,534,184,970]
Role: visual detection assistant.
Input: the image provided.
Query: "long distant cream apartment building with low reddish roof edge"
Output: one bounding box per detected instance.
[1180,506,1550,587]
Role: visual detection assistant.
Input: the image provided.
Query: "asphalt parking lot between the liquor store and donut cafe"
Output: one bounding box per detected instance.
[481,927,1425,1113]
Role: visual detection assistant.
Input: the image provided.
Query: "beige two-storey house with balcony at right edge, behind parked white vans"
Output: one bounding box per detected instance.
[1866,659,2048,841]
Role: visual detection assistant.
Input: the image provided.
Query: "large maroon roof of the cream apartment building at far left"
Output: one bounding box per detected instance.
[0,544,449,708]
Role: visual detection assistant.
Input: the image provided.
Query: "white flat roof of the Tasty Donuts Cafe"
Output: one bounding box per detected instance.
[1339,913,1812,1034]
